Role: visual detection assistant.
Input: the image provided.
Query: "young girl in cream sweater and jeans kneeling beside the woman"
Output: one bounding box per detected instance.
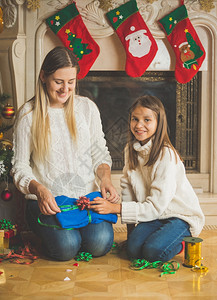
[91,96,204,262]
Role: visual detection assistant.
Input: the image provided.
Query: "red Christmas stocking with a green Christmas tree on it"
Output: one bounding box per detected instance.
[46,2,99,79]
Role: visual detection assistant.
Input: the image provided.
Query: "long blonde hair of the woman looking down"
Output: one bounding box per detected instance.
[31,46,79,161]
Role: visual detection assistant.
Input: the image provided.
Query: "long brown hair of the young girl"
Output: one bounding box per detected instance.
[128,95,181,170]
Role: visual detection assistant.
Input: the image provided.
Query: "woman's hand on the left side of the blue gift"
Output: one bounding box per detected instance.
[29,180,61,215]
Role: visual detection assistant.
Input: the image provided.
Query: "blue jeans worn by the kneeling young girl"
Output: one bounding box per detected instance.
[127,218,191,262]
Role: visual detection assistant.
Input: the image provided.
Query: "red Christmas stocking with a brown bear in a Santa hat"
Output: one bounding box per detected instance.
[159,0,205,83]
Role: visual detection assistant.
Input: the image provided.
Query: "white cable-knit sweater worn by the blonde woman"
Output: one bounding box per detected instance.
[11,96,111,200]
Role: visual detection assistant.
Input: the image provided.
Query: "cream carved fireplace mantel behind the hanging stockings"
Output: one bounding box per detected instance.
[0,0,217,223]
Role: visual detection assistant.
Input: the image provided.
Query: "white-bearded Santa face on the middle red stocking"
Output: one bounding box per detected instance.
[125,26,151,58]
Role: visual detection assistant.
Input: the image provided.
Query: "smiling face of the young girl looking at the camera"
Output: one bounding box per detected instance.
[130,106,157,145]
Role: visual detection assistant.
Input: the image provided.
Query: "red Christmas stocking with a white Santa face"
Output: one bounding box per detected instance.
[106,0,157,77]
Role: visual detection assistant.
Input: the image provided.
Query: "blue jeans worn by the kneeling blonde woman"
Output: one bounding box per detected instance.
[26,200,114,261]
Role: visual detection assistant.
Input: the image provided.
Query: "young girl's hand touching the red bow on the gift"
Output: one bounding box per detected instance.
[90,197,121,215]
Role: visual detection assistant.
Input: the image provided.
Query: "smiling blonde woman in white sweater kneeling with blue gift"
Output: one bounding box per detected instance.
[12,47,119,260]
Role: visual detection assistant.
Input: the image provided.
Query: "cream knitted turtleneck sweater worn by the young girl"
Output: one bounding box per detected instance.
[121,140,205,236]
